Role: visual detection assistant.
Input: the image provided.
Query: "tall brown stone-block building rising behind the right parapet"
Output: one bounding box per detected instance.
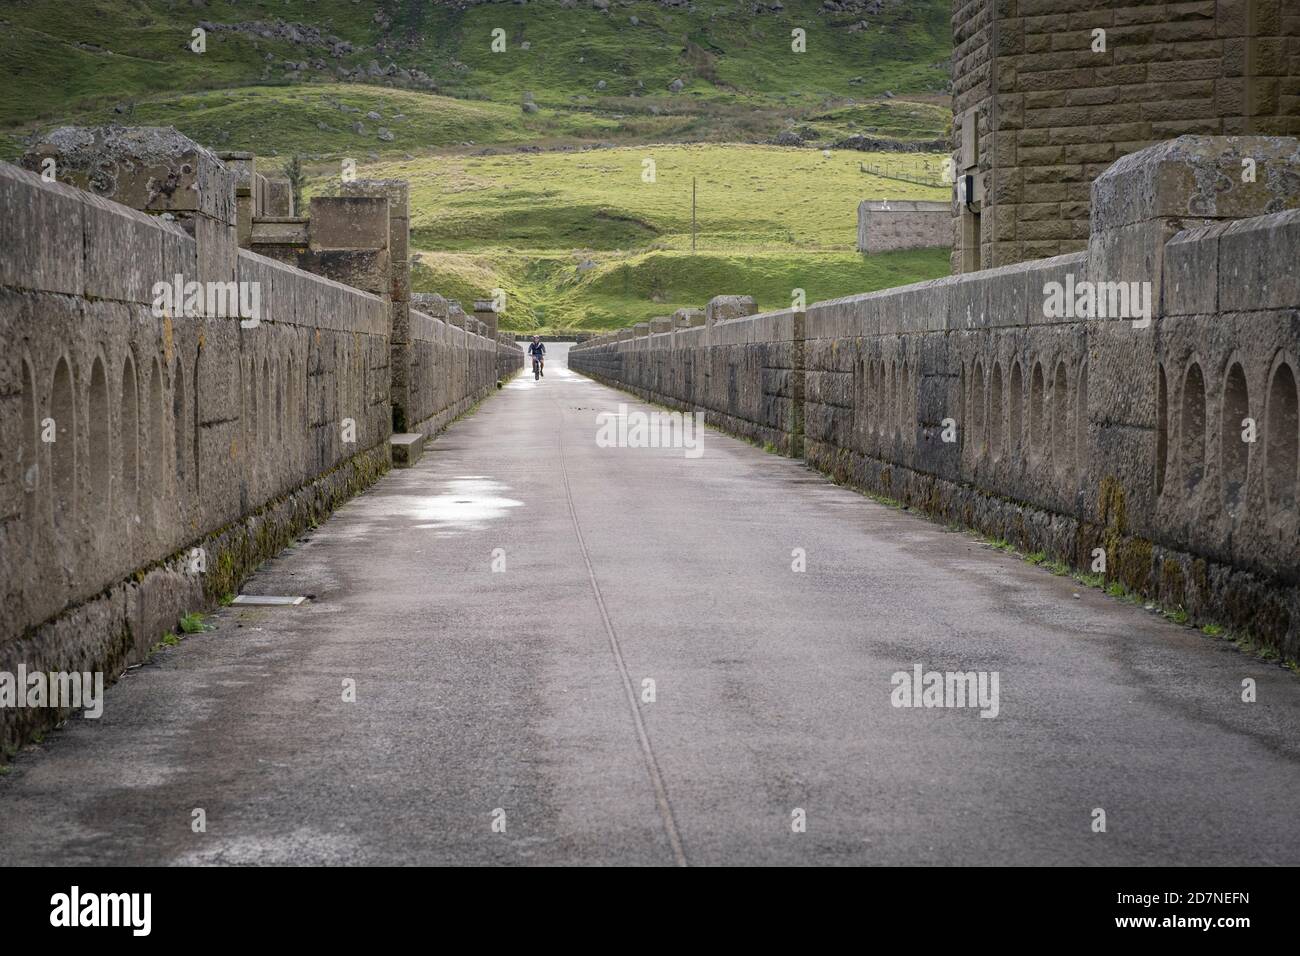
[952,0,1300,273]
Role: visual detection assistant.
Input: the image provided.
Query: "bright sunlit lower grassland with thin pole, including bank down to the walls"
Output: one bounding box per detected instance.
[366,144,949,330]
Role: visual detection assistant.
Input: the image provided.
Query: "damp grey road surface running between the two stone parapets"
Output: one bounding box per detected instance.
[0,346,1300,865]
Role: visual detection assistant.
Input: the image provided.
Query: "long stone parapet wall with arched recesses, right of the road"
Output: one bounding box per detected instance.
[569,137,1300,658]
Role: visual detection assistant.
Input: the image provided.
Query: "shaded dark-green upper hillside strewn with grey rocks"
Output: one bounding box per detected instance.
[0,0,950,156]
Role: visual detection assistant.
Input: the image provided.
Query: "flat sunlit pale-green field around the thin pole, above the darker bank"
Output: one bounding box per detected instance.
[363,144,948,252]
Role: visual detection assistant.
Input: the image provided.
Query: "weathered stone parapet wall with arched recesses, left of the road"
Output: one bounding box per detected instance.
[0,130,523,762]
